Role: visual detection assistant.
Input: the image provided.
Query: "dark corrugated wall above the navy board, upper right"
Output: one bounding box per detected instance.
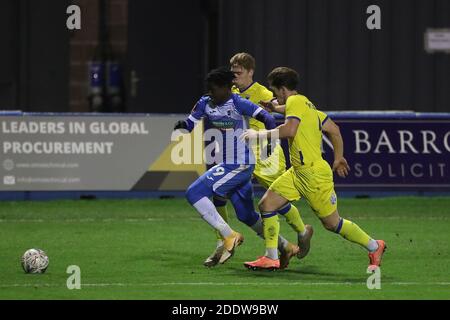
[216,0,450,112]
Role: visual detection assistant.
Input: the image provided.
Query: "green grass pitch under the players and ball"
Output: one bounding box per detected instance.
[0,197,450,300]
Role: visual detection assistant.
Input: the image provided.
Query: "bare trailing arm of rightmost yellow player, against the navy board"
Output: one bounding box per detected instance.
[322,119,350,178]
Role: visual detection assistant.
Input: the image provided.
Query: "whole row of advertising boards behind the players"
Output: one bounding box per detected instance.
[0,111,450,200]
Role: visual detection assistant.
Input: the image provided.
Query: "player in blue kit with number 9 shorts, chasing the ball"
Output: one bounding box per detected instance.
[174,68,298,263]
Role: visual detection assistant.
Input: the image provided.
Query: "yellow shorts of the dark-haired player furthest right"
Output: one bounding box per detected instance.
[269,159,337,218]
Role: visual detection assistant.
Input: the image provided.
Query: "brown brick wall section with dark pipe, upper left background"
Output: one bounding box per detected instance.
[69,0,128,112]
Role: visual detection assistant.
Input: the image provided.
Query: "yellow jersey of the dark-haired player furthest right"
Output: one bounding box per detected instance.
[286,94,328,168]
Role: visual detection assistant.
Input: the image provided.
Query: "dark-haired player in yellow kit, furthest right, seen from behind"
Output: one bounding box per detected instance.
[242,67,386,269]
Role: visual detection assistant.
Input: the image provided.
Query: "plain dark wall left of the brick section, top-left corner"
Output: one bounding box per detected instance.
[0,0,70,112]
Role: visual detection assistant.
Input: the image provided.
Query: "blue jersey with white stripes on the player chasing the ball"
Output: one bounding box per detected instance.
[187,94,275,164]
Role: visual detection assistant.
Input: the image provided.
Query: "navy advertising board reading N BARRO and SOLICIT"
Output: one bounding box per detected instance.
[280,112,450,191]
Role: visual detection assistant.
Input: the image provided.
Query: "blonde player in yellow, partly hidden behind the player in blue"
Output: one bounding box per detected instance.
[203,52,312,268]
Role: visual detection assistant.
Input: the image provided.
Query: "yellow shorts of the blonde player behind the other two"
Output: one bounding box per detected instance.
[253,144,286,189]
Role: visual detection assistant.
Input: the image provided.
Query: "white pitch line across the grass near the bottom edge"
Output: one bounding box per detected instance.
[0,282,450,288]
